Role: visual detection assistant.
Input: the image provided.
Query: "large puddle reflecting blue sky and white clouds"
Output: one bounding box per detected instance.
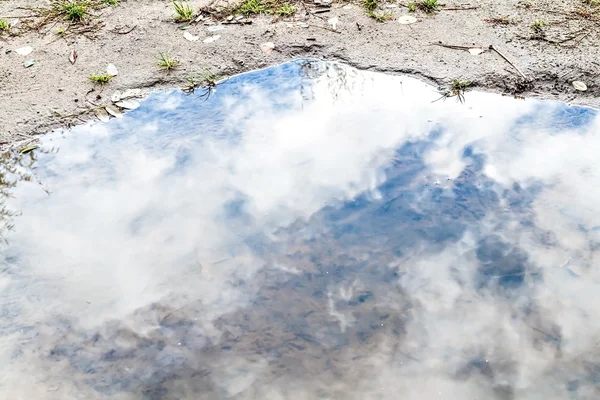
[0,62,600,400]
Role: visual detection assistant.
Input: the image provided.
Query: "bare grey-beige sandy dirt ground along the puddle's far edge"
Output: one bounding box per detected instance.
[0,0,600,147]
